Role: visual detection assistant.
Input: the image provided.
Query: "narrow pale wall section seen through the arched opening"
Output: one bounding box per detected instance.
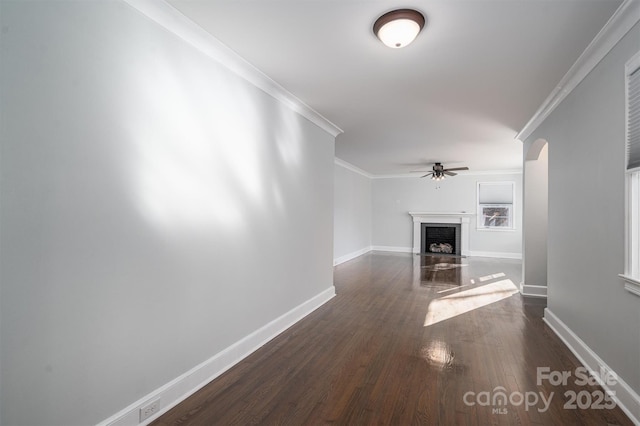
[523,141,549,296]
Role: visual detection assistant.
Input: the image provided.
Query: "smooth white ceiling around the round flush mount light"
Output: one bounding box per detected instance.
[168,0,621,175]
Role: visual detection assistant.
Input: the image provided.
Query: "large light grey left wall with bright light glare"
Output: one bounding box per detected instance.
[0,0,334,426]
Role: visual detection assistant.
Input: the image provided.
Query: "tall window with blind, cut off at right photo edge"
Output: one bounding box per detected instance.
[621,52,640,296]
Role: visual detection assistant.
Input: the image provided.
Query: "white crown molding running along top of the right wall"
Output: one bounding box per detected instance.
[515,0,640,141]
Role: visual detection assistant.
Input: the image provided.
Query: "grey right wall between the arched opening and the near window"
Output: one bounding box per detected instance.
[525,20,640,412]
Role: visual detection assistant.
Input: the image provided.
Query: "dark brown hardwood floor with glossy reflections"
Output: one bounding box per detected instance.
[153,252,632,426]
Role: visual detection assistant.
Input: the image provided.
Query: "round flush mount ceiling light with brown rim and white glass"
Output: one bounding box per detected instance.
[373,9,425,49]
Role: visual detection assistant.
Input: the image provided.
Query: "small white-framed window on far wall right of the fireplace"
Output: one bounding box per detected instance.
[478,182,515,229]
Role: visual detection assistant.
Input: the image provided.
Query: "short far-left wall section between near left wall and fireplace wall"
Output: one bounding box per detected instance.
[333,163,371,264]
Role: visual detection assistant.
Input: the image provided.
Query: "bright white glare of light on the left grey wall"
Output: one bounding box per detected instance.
[123,51,302,232]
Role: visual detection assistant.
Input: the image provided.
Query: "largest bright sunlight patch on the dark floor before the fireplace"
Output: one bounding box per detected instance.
[424,280,518,327]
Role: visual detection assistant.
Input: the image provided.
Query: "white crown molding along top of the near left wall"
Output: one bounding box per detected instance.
[124,0,343,137]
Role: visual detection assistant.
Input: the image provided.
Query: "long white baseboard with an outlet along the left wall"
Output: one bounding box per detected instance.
[98,286,336,426]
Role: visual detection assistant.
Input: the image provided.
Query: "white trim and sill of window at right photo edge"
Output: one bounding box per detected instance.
[618,52,640,296]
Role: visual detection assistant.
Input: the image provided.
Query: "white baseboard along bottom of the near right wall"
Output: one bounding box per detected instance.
[543,308,640,425]
